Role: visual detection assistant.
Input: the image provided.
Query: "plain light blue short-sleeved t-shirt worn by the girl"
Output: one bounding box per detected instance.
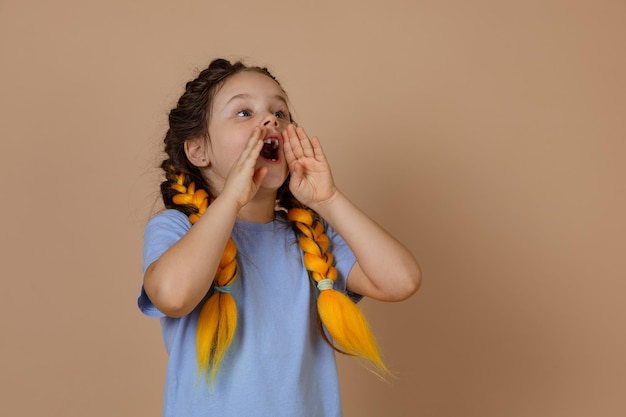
[138,210,356,417]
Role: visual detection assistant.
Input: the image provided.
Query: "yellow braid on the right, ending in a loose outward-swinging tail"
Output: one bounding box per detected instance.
[288,208,390,378]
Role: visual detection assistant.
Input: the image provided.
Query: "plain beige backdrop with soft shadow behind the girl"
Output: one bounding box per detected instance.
[0,0,626,417]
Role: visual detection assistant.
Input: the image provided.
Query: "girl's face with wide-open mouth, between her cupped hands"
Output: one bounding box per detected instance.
[205,71,290,193]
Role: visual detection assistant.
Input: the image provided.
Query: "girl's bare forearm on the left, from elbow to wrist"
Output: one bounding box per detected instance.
[144,194,239,317]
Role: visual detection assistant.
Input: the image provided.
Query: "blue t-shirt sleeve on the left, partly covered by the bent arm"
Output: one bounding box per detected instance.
[137,210,191,317]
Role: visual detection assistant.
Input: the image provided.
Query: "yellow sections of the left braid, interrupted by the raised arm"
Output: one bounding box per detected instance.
[171,173,237,383]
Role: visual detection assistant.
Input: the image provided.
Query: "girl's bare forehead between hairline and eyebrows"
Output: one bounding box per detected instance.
[213,71,287,106]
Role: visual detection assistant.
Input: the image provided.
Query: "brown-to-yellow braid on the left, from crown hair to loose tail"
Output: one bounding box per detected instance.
[161,59,288,381]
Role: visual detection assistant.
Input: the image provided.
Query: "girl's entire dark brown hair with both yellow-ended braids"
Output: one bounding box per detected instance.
[161,59,389,381]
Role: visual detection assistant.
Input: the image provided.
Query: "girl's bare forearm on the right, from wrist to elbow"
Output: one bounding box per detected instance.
[312,191,421,301]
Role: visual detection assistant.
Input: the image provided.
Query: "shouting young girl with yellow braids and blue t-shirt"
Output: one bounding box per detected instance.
[138,59,420,417]
